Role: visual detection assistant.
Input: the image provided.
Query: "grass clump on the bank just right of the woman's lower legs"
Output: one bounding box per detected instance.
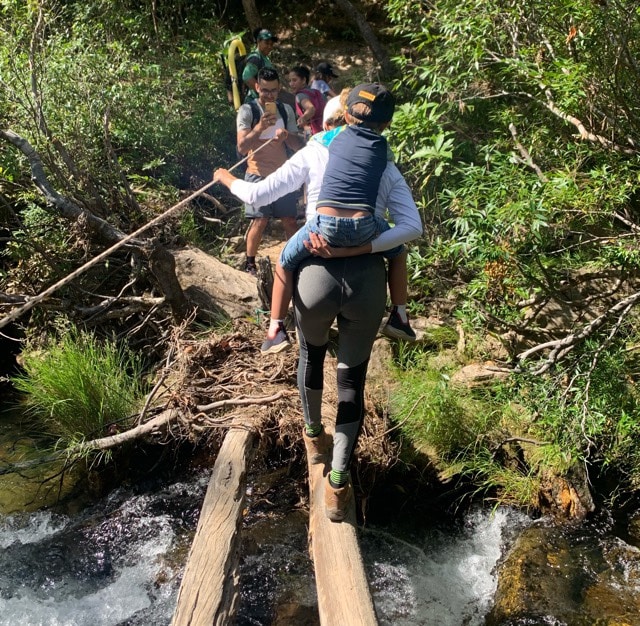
[391,351,539,506]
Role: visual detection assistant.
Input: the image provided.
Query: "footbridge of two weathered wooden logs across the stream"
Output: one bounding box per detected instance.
[171,422,378,626]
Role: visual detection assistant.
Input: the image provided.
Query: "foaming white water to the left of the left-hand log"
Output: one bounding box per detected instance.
[0,477,206,626]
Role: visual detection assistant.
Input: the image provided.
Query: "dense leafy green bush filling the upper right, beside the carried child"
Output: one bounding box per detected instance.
[387,0,640,330]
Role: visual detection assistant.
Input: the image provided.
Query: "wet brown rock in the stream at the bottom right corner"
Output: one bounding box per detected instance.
[486,525,640,626]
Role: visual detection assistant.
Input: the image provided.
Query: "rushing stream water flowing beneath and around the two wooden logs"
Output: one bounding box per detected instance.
[0,402,640,626]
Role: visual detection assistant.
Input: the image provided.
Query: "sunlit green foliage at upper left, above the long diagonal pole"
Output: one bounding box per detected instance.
[0,0,234,214]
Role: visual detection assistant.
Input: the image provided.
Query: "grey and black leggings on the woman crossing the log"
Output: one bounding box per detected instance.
[293,254,386,471]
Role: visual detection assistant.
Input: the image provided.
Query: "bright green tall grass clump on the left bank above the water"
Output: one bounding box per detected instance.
[13,331,143,447]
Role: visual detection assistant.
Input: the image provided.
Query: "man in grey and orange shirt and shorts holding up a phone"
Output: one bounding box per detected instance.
[236,68,304,276]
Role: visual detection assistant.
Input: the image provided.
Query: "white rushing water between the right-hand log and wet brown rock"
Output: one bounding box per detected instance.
[362,509,526,626]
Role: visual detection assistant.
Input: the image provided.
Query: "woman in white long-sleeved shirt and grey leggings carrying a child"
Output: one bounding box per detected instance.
[214,85,422,522]
